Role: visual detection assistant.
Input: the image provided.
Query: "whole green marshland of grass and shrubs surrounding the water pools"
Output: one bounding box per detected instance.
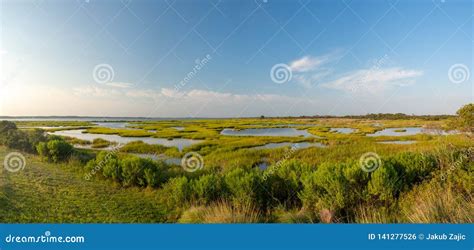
[0,113,474,223]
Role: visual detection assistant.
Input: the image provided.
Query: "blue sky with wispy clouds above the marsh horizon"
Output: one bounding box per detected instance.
[0,0,474,117]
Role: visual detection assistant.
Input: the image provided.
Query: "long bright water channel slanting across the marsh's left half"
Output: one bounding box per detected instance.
[50,129,202,151]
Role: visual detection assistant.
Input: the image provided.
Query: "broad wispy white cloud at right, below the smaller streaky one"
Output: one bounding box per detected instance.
[321,67,423,94]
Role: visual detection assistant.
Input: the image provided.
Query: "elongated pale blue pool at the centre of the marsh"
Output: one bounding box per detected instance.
[221,128,313,137]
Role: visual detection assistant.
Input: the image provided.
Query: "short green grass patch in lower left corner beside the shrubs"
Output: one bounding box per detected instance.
[0,147,165,223]
